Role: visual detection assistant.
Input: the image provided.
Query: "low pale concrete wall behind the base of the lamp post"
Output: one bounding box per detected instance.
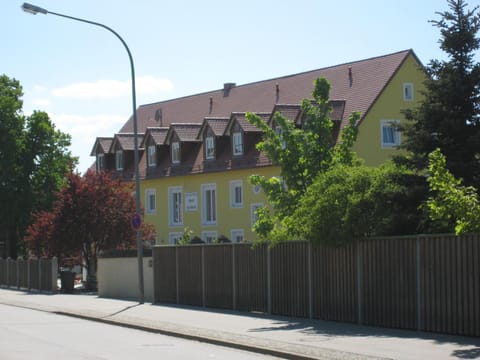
[97,257,153,302]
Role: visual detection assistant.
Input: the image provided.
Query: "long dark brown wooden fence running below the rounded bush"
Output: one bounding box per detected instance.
[153,235,480,336]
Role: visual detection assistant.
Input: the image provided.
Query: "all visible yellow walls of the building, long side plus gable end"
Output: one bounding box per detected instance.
[141,54,425,244]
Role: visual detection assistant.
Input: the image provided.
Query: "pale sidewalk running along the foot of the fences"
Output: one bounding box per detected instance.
[0,288,480,359]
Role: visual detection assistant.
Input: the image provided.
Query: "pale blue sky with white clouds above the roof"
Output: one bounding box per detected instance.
[0,0,480,172]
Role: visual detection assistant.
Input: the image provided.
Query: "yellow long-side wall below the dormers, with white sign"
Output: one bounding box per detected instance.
[141,166,279,244]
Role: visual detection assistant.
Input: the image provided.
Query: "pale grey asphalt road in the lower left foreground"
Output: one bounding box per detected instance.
[0,305,280,360]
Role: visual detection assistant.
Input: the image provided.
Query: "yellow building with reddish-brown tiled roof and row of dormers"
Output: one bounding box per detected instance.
[92,50,425,244]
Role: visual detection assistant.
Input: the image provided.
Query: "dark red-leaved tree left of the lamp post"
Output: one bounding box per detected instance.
[25,171,153,289]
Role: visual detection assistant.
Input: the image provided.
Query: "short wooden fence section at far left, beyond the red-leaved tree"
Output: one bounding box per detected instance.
[0,258,58,292]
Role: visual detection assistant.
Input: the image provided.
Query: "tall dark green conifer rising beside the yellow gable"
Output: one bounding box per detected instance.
[397,0,480,188]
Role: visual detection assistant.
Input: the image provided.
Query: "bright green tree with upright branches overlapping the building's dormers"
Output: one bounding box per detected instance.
[247,78,360,241]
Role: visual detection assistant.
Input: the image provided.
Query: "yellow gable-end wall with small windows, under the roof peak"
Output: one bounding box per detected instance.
[353,54,426,166]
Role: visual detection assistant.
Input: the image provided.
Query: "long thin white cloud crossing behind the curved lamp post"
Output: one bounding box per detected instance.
[52,76,173,99]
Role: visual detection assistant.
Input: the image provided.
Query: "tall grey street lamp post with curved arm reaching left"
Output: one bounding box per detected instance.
[22,3,145,304]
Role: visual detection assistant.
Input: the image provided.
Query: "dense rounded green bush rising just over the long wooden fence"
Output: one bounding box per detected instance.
[288,162,411,245]
